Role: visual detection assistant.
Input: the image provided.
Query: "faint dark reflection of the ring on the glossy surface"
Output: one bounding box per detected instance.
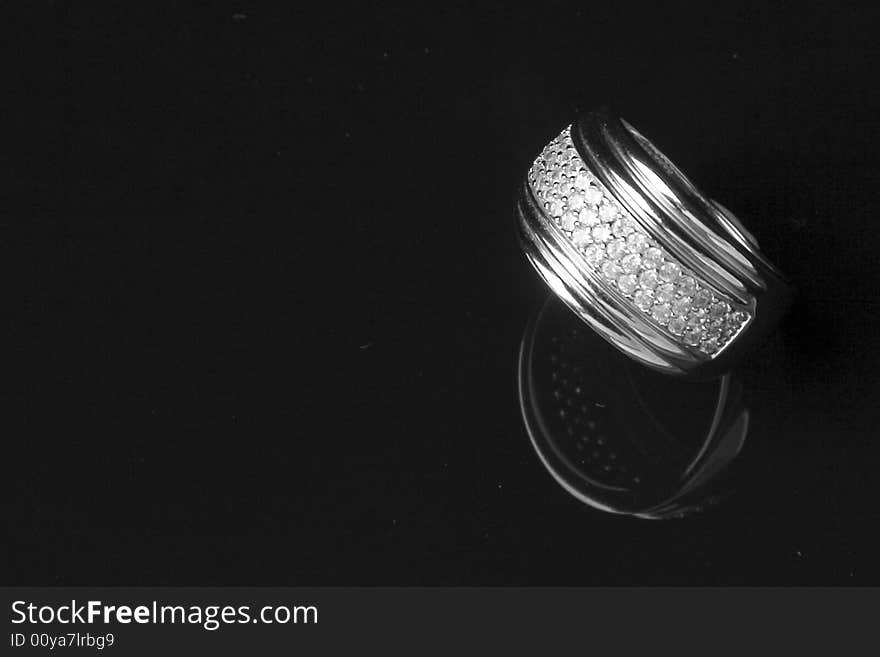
[518,297,749,519]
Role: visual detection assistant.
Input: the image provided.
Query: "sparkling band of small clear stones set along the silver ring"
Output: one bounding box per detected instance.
[529,126,750,355]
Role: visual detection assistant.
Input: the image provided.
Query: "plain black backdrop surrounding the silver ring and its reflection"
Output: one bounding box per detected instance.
[0,3,880,585]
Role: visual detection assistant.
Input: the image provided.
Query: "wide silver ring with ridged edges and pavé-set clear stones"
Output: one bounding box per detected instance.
[517,110,791,377]
